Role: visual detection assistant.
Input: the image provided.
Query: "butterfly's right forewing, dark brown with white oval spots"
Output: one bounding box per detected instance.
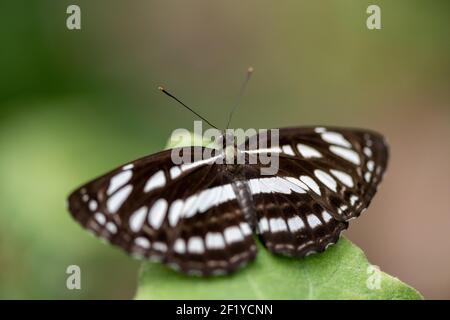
[244,127,388,221]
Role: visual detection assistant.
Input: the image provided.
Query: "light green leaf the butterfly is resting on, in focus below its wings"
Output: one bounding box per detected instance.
[135,131,423,299]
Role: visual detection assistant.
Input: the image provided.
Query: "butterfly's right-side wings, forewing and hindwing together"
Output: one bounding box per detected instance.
[241,127,388,256]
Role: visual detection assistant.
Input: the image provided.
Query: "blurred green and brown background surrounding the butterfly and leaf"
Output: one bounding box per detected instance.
[0,0,450,299]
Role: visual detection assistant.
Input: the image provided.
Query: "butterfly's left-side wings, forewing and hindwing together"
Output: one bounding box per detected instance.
[68,147,256,275]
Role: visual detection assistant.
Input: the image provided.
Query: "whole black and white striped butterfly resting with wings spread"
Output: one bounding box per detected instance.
[68,127,388,275]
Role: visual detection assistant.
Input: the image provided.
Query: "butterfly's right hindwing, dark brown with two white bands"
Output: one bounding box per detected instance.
[236,162,348,257]
